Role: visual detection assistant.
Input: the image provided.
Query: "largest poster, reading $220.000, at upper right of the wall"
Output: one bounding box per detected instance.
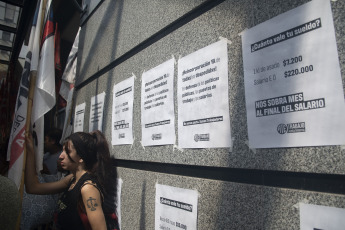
[242,0,345,148]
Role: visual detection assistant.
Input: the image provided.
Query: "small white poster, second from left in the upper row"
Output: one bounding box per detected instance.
[89,92,105,132]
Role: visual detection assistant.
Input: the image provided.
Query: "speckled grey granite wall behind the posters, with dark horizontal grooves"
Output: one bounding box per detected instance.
[75,0,345,229]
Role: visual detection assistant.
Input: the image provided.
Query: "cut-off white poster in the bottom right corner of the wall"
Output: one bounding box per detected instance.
[300,203,345,230]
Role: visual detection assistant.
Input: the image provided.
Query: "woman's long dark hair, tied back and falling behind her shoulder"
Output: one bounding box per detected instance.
[65,130,117,213]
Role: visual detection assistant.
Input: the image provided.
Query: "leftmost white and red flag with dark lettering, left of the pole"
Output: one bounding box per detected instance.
[7,1,42,189]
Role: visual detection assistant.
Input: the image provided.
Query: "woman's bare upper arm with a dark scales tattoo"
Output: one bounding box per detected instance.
[81,184,107,230]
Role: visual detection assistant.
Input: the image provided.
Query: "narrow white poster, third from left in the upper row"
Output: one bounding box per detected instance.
[111,76,134,145]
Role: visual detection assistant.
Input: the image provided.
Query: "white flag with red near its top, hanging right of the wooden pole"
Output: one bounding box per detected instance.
[31,0,56,171]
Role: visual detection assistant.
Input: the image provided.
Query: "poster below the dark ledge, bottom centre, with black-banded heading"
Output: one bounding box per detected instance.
[155,184,198,230]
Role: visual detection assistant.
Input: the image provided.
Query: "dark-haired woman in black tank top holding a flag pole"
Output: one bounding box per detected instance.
[25,131,119,230]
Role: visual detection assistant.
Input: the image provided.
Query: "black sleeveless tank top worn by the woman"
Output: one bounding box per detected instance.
[56,173,119,230]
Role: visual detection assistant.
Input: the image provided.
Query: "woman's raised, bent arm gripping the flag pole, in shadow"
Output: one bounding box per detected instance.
[25,133,72,195]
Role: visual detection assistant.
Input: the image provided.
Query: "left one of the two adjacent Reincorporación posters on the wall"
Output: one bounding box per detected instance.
[141,59,175,146]
